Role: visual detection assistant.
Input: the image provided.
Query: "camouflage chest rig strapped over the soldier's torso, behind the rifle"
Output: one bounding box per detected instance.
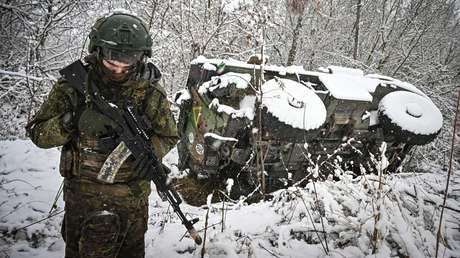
[60,61,161,183]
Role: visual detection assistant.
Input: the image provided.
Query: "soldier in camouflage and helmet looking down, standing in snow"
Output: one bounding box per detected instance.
[26,12,178,257]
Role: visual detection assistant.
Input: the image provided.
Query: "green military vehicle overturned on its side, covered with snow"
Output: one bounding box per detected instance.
[175,57,442,192]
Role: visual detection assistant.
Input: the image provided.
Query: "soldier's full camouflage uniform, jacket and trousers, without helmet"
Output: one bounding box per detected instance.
[26,56,178,257]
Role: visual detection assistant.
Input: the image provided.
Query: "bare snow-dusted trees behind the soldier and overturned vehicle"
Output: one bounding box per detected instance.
[0,0,460,168]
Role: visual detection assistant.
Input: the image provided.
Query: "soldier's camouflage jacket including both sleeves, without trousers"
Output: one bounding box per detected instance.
[26,60,178,189]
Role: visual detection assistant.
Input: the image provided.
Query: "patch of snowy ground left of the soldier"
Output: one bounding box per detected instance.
[0,140,64,257]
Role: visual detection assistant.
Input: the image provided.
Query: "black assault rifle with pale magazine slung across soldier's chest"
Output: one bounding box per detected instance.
[59,60,201,245]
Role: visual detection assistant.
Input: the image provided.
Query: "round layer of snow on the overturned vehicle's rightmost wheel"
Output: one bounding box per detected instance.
[379,91,443,135]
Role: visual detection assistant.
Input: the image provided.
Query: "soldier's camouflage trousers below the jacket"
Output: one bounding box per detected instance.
[61,180,148,258]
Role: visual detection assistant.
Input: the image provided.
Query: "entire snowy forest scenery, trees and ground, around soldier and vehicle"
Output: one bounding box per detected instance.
[0,0,460,258]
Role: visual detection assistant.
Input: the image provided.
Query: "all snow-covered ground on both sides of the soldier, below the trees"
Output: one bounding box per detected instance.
[0,140,460,258]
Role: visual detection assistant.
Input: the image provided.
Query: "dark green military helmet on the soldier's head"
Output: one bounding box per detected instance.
[88,12,152,57]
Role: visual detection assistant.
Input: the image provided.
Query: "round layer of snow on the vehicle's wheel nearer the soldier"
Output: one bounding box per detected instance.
[262,79,326,130]
